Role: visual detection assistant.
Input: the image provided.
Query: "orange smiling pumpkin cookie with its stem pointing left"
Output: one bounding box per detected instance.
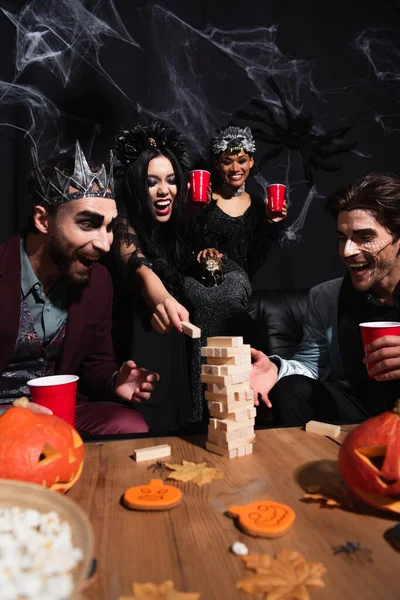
[227,500,296,538]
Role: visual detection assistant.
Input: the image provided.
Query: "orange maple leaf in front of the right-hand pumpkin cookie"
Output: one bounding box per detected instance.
[236,549,325,600]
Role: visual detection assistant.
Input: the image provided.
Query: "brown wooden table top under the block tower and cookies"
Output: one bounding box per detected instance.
[68,428,400,600]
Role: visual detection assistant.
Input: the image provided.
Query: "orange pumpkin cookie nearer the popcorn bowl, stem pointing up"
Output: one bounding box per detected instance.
[123,479,182,510]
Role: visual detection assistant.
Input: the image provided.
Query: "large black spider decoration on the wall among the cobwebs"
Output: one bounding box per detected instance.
[232,77,358,188]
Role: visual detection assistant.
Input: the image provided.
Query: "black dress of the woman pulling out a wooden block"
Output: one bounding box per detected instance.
[107,227,193,433]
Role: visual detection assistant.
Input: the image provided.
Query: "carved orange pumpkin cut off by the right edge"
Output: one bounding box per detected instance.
[339,400,400,513]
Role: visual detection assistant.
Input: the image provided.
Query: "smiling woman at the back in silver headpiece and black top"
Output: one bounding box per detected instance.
[190,127,287,277]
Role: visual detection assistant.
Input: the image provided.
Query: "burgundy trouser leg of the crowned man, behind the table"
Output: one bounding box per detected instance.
[76,400,149,435]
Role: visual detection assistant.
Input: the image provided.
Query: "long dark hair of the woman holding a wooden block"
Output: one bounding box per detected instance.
[115,146,186,293]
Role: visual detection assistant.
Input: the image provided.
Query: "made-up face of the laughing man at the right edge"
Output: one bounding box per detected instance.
[338,209,400,291]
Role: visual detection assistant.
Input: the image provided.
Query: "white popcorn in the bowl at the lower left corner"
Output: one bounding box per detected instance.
[0,507,83,600]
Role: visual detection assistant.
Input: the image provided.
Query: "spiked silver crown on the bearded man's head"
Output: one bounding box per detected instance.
[32,140,115,206]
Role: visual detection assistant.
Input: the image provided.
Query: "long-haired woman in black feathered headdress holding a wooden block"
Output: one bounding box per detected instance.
[109,121,193,431]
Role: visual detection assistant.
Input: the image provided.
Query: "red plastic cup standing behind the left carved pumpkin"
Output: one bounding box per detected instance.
[28,375,79,427]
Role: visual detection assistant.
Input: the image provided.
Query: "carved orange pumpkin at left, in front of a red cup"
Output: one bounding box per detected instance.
[0,408,85,492]
